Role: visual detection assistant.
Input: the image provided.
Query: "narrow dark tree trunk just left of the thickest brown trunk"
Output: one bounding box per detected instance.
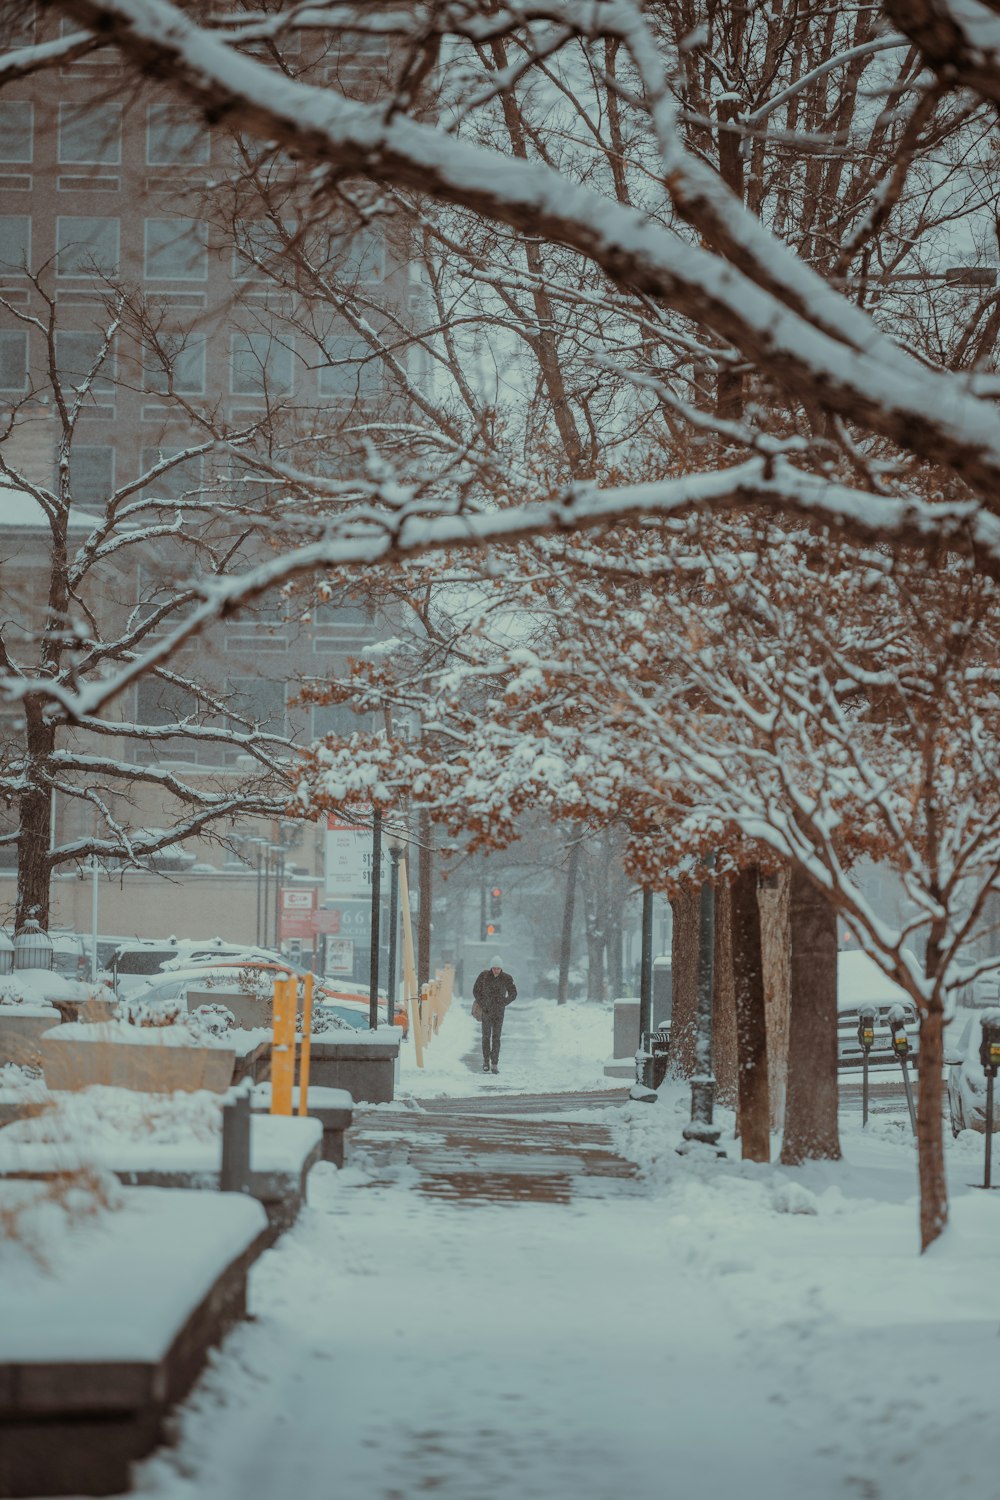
[732,866,771,1161]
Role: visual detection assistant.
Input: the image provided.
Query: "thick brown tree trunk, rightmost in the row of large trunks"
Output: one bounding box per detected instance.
[781,863,840,1167]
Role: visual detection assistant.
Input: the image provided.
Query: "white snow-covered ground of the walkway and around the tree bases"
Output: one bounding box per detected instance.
[111,1001,1000,1500]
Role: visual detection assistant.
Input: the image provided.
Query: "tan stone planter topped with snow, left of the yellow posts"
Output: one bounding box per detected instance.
[40,1025,235,1094]
